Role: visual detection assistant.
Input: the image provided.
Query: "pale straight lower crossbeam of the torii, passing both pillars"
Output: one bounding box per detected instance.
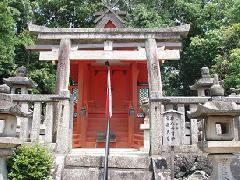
[39,49,180,61]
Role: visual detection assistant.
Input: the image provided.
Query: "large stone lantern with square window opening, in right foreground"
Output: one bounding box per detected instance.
[189,75,240,180]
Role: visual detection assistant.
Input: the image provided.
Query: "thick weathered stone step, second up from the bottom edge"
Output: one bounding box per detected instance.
[65,154,151,170]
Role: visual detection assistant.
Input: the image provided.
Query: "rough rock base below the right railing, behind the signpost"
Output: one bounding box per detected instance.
[158,152,212,180]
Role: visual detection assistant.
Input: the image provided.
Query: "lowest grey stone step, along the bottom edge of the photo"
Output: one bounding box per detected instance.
[62,168,153,180]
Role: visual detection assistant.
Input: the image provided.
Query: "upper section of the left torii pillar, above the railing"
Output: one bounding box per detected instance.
[56,39,71,94]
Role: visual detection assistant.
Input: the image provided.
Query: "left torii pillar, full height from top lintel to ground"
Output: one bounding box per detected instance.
[53,39,71,153]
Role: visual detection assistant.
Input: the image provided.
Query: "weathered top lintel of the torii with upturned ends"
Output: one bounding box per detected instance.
[28,24,190,42]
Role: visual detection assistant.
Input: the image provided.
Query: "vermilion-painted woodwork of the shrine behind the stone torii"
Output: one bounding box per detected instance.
[69,18,148,148]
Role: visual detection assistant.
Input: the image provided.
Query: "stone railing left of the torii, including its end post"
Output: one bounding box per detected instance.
[11,92,73,153]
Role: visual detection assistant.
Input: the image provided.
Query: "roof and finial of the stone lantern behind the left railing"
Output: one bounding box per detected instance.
[3,66,36,88]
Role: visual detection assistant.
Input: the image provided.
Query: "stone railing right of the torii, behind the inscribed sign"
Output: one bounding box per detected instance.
[152,96,240,152]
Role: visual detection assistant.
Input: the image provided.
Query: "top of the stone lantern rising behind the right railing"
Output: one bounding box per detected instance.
[190,67,213,96]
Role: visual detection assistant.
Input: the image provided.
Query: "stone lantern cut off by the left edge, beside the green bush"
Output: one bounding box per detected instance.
[0,85,28,180]
